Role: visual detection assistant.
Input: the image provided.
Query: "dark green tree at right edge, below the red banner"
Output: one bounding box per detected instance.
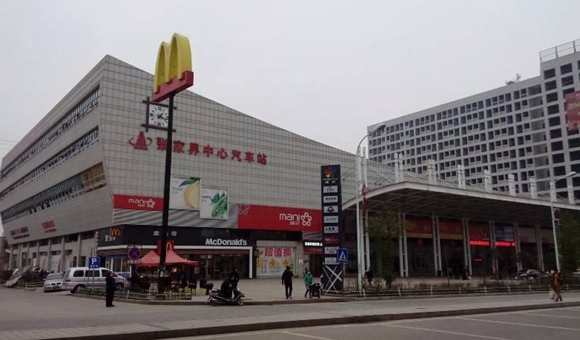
[556,214,580,274]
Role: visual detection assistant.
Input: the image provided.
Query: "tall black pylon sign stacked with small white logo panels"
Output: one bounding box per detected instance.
[320,165,343,291]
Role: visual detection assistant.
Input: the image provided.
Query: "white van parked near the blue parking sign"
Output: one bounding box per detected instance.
[63,267,125,293]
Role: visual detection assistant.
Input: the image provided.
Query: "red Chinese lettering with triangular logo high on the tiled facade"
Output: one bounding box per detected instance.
[129,131,268,165]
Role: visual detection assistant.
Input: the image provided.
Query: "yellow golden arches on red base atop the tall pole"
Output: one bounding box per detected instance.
[151,33,193,102]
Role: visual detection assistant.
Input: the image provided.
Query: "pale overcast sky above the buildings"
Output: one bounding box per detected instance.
[0,0,580,232]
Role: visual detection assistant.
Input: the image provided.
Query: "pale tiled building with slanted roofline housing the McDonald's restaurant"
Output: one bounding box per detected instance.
[0,56,354,278]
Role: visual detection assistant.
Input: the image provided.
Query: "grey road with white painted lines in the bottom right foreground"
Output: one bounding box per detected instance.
[167,307,580,340]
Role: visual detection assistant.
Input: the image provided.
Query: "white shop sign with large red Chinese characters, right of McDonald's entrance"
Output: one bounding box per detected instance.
[256,247,296,277]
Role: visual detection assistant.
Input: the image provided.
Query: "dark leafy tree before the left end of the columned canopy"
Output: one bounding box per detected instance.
[367,204,403,286]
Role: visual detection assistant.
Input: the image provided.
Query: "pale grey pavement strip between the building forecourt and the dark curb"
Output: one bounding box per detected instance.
[0,288,580,340]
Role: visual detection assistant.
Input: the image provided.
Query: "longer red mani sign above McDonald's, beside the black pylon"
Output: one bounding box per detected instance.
[238,205,322,232]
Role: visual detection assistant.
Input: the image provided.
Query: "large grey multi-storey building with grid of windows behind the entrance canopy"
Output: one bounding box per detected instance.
[369,40,580,199]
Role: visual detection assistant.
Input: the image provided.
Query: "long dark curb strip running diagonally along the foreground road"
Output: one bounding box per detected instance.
[34,302,580,340]
